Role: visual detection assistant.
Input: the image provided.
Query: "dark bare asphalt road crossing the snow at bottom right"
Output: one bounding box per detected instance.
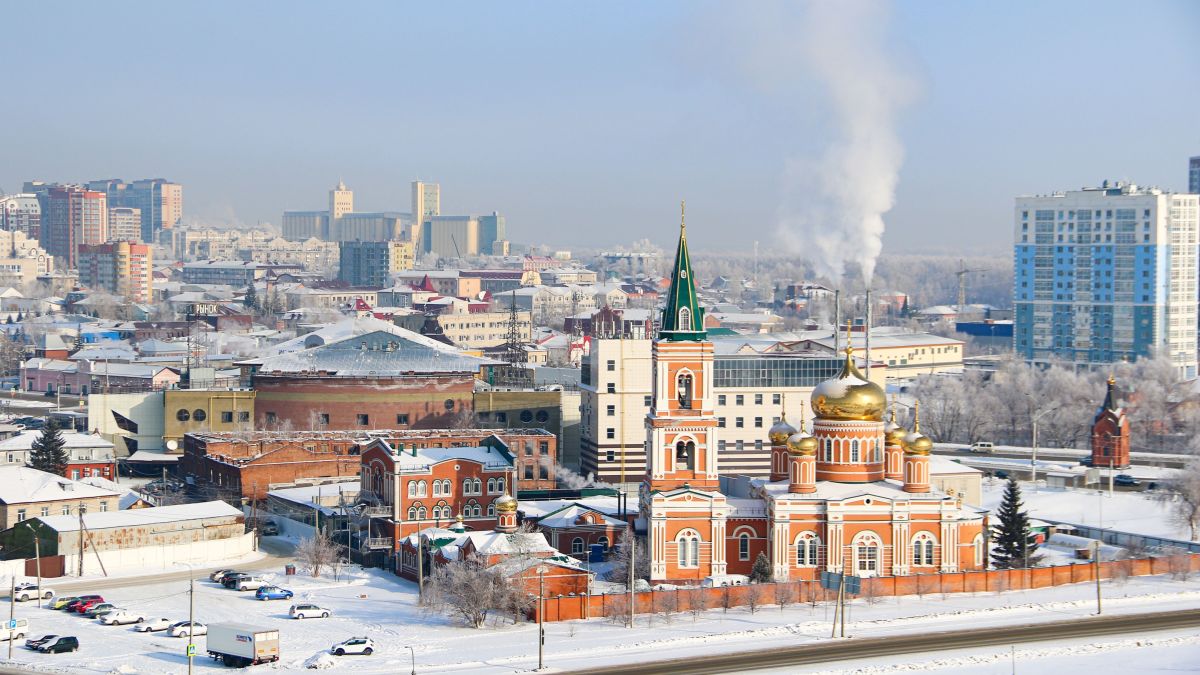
[572,609,1200,675]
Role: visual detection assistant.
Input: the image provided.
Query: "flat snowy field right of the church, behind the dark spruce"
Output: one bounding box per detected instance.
[982,479,1188,540]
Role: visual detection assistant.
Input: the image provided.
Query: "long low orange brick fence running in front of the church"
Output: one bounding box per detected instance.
[529,552,1200,621]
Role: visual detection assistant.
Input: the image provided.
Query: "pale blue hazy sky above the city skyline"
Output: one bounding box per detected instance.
[0,0,1200,253]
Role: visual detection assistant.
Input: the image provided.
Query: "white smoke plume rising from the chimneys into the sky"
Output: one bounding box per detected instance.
[780,0,913,286]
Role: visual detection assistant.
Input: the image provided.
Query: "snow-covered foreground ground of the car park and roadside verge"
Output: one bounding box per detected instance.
[0,571,1200,675]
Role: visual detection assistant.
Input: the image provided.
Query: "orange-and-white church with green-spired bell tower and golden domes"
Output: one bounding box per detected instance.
[640,211,986,581]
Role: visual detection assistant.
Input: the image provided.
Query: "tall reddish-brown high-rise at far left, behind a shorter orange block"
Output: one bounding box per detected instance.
[38,185,108,269]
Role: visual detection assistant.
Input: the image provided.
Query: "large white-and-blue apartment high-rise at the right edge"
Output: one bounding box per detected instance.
[1013,181,1200,377]
